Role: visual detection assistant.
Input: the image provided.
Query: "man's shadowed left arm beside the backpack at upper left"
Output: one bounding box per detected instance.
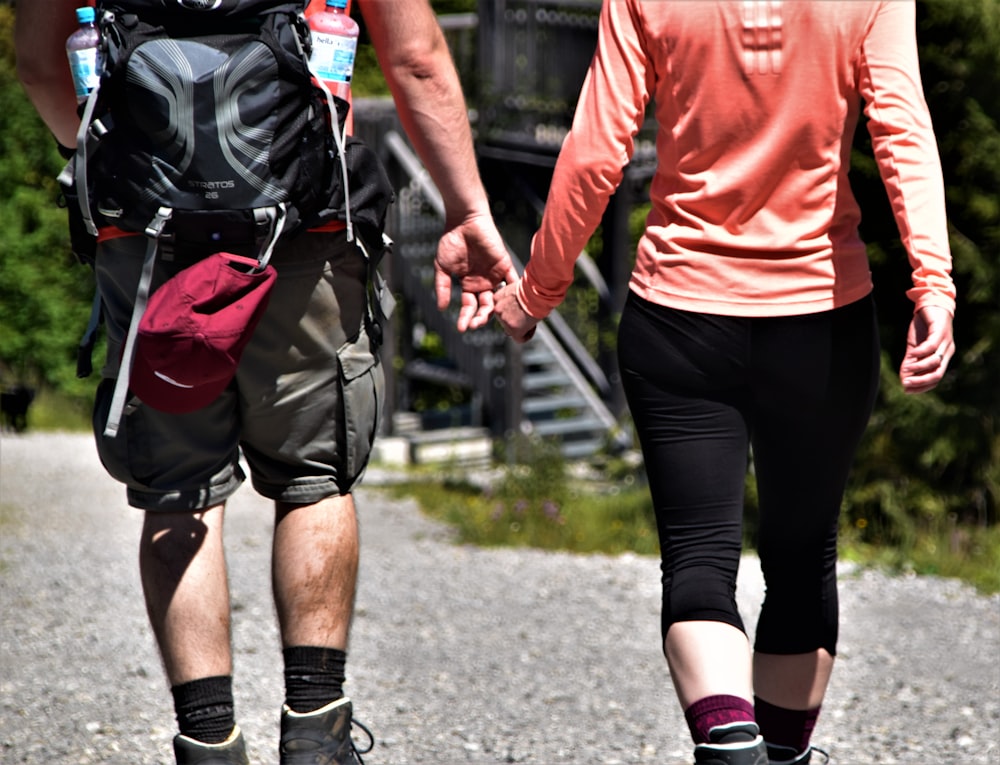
[14,0,80,146]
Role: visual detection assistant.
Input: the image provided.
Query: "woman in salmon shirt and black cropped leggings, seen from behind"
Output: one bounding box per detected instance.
[496,0,955,765]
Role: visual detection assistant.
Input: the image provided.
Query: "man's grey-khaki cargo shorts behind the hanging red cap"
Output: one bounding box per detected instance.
[94,233,385,512]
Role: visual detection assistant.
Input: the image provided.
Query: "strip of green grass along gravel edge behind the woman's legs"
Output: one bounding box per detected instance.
[376,436,1000,594]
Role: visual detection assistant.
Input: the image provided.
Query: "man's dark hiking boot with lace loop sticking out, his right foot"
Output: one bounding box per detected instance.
[278,697,375,765]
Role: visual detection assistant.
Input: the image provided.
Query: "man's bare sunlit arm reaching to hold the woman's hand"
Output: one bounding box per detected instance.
[358,0,517,330]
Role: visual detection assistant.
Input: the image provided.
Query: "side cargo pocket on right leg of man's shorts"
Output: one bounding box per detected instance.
[337,327,385,484]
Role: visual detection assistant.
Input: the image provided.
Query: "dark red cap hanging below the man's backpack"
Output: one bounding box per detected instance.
[129,252,277,414]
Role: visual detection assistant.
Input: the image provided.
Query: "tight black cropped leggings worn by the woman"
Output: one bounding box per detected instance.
[618,293,879,654]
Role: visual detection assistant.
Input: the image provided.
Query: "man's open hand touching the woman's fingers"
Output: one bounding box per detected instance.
[434,214,517,332]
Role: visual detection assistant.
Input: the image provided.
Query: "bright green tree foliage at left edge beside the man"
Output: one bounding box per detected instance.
[0,4,94,397]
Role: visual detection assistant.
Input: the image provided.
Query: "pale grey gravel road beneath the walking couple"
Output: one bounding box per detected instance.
[0,434,1000,765]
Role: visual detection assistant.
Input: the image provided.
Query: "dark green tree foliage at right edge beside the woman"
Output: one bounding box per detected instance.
[848,0,1000,542]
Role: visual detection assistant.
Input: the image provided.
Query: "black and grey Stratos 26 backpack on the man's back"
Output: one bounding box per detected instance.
[60,0,393,432]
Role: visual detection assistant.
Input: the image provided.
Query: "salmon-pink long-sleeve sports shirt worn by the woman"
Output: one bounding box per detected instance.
[517,0,955,318]
